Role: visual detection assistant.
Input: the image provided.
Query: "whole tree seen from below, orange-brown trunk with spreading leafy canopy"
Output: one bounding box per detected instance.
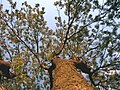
[0,0,120,90]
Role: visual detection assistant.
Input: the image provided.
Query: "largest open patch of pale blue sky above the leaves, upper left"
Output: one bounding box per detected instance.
[0,0,58,29]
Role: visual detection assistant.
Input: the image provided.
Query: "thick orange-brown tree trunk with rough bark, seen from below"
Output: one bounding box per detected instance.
[52,58,94,90]
